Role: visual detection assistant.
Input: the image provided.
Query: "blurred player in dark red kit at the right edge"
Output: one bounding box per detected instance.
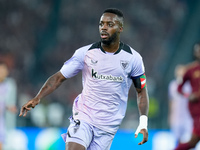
[176,43,200,150]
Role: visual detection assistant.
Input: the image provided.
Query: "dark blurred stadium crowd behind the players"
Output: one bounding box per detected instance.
[0,0,200,129]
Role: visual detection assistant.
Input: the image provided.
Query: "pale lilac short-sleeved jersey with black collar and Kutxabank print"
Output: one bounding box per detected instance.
[60,42,144,133]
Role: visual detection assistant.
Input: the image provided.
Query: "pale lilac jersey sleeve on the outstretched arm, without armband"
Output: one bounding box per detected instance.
[60,48,85,78]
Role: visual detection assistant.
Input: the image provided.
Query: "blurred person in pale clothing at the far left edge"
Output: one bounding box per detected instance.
[0,62,17,150]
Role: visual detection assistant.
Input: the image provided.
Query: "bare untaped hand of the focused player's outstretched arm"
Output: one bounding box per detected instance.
[19,98,40,117]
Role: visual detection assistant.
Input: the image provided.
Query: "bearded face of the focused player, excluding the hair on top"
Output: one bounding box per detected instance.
[99,13,123,45]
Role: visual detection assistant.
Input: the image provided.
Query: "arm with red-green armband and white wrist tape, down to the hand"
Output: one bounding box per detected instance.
[132,74,149,145]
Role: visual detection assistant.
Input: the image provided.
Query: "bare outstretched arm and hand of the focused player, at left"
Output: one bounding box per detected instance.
[19,71,66,116]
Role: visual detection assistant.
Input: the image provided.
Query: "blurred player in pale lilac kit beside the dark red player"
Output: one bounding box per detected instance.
[168,65,192,148]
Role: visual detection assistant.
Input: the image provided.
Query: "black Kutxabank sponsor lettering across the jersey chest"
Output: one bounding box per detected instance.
[92,69,123,82]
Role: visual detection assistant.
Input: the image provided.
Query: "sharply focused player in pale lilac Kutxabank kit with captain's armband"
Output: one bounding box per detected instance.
[20,9,149,150]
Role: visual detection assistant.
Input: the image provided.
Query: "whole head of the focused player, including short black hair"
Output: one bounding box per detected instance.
[99,8,124,45]
